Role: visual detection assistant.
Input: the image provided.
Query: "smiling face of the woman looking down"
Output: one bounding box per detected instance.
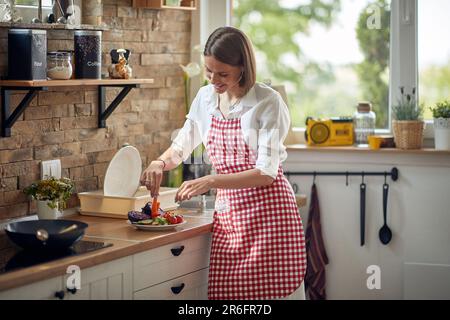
[205,56,242,94]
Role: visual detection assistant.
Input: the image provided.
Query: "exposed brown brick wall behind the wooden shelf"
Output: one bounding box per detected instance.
[0,0,191,220]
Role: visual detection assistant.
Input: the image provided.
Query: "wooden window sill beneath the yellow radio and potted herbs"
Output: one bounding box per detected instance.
[286,144,450,155]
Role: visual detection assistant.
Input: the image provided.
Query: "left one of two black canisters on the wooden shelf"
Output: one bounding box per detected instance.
[8,29,47,80]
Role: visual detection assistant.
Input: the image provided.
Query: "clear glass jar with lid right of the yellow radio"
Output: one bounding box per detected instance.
[353,102,376,145]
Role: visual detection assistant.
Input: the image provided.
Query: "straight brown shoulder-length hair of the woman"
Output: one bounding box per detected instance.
[203,27,256,95]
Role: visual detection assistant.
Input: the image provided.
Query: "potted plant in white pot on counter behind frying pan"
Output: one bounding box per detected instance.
[23,177,75,219]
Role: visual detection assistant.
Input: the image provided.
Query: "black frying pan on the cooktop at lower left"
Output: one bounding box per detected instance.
[5,220,88,250]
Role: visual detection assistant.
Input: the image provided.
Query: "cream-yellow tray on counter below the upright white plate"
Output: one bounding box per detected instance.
[78,187,178,219]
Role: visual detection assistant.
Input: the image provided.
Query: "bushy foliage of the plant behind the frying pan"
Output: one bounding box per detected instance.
[23,177,75,210]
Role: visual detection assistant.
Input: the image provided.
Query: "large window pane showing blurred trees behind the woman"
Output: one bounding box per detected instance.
[233,0,392,129]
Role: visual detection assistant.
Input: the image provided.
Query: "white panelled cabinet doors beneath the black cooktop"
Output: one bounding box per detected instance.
[0,257,132,300]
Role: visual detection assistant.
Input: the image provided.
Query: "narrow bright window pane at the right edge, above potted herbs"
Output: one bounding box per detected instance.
[418,0,450,119]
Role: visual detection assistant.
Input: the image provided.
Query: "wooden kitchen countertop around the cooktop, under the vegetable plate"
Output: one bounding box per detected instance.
[0,209,212,291]
